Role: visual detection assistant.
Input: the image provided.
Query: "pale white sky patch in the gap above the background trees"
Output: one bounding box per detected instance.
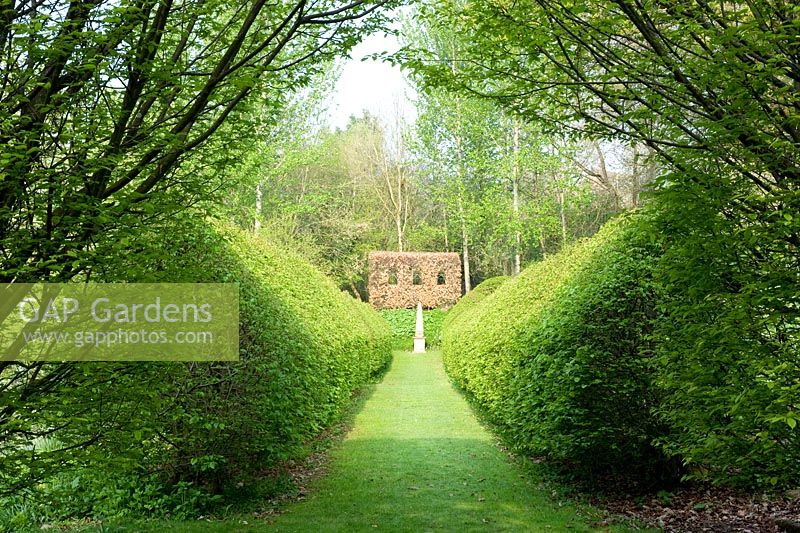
[327,29,416,129]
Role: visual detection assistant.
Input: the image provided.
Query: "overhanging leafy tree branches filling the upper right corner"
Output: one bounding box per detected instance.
[407,0,800,256]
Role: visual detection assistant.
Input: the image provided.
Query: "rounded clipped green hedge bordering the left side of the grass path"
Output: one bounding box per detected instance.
[122,218,391,482]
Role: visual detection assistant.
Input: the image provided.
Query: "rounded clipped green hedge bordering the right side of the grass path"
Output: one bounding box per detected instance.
[443,216,674,479]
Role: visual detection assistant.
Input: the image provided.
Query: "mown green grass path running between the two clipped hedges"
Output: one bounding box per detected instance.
[76,352,648,533]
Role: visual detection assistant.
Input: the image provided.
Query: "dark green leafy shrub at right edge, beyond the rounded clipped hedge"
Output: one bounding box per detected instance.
[655,187,800,488]
